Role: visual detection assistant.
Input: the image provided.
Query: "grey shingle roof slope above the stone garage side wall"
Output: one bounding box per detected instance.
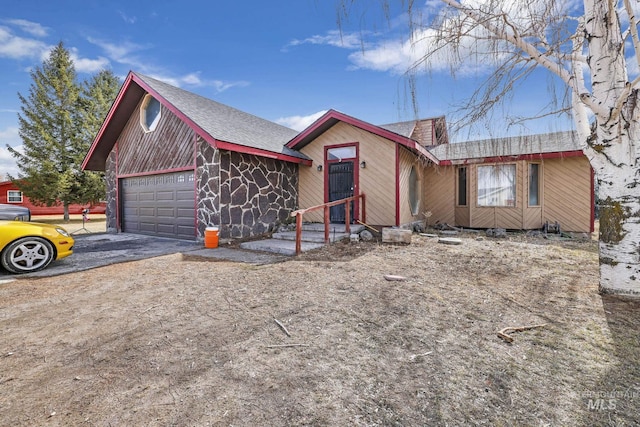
[134,73,307,159]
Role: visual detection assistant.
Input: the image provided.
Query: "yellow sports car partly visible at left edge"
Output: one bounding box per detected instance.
[0,221,74,274]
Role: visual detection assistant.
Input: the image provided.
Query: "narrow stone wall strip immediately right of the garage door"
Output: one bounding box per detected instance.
[196,141,222,238]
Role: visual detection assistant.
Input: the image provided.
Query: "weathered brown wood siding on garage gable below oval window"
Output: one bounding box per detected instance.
[118,98,195,175]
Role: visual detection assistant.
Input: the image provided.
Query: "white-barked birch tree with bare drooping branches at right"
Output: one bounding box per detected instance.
[339,0,640,294]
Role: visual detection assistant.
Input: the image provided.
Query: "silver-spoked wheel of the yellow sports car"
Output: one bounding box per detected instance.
[1,237,53,273]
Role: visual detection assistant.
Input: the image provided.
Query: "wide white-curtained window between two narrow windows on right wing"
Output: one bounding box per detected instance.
[478,165,516,207]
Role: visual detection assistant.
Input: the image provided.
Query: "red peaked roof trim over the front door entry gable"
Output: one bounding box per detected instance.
[287,110,438,163]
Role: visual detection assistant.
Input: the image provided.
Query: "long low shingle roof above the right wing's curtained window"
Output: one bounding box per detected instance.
[429,132,582,161]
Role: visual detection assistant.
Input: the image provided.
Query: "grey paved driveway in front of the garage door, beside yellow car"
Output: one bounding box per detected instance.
[0,233,289,282]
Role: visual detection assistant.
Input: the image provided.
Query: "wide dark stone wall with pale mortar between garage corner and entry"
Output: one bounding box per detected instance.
[219,151,298,238]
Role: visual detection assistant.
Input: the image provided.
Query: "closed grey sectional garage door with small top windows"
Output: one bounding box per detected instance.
[121,171,196,239]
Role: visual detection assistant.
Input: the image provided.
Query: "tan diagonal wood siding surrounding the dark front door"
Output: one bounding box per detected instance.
[299,122,396,225]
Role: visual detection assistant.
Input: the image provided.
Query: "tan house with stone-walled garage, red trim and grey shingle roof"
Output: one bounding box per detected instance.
[83,72,593,239]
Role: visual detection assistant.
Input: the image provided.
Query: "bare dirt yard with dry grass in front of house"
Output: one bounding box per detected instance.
[0,227,640,426]
